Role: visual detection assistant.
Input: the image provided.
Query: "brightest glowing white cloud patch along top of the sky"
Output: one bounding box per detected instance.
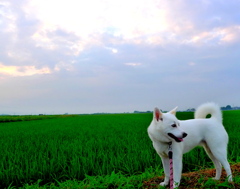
[24,0,186,46]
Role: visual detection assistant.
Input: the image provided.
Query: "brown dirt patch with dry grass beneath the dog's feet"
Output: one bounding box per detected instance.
[144,163,240,189]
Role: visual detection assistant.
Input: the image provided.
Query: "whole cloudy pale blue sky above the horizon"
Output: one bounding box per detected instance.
[0,0,240,114]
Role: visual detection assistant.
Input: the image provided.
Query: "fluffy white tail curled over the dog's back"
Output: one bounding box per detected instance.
[194,102,222,123]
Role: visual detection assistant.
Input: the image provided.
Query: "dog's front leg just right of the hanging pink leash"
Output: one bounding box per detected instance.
[173,153,182,188]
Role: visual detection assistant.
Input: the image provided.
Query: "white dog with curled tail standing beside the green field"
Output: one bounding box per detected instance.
[148,103,232,187]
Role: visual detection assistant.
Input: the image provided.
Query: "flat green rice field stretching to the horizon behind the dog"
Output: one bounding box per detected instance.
[0,110,240,188]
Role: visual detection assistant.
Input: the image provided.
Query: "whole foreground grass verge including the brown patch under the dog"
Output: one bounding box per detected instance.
[7,163,240,189]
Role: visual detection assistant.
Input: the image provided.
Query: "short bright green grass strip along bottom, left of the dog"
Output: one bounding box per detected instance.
[15,167,163,189]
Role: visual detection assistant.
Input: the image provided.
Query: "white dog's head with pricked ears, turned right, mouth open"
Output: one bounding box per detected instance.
[153,107,187,142]
